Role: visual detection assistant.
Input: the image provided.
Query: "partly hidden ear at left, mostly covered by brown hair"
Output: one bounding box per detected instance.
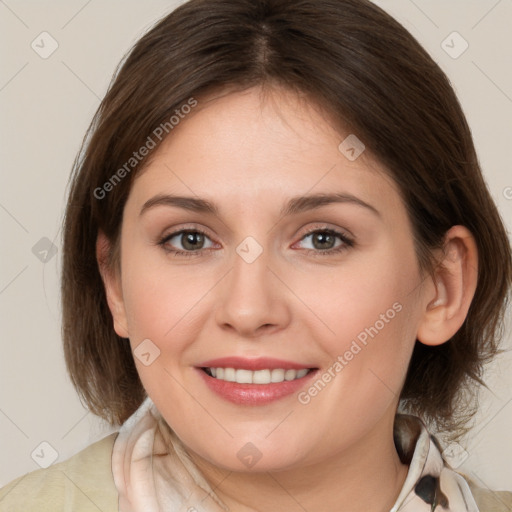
[96,230,129,338]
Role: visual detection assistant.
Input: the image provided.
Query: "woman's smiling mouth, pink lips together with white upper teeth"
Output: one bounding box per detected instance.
[196,357,319,406]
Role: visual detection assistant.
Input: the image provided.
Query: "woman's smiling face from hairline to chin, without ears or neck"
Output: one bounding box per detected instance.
[108,88,432,471]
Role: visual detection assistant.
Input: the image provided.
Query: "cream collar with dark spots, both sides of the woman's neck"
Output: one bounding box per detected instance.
[112,397,479,512]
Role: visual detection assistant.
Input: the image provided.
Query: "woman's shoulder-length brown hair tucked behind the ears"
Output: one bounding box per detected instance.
[62,0,512,438]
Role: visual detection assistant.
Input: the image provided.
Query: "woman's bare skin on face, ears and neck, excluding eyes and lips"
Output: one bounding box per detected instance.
[97,88,477,512]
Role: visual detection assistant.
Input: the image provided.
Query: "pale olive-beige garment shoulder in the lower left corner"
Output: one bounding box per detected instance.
[0,432,118,512]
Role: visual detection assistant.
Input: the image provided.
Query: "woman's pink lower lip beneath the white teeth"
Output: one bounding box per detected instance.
[196,368,317,405]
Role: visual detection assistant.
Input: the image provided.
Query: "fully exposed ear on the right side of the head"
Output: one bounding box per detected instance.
[416,226,478,345]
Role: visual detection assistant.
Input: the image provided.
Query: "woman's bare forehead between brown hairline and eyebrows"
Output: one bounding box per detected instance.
[126,83,398,218]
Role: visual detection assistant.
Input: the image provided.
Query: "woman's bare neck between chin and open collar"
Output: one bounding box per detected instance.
[191,415,408,512]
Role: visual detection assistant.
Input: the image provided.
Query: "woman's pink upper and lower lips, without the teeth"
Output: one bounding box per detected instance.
[195,357,318,406]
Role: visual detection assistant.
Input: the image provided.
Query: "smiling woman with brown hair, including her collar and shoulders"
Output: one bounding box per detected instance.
[0,0,512,512]
